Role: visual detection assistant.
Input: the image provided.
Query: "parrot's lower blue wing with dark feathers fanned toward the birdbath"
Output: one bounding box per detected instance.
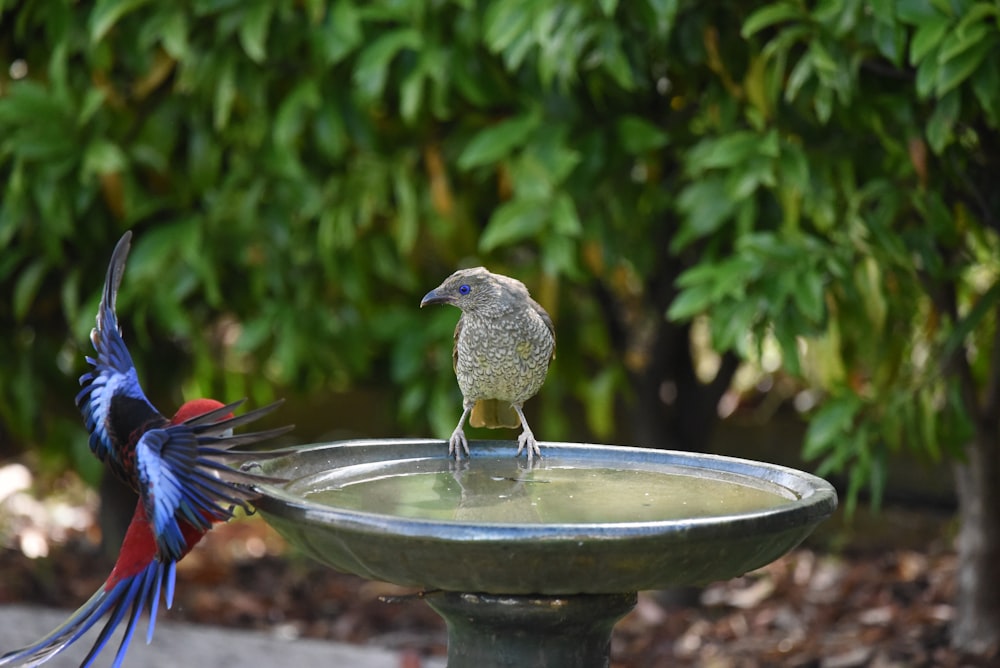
[135,402,291,560]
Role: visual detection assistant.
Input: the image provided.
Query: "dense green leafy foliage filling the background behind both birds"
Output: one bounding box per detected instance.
[0,0,1000,649]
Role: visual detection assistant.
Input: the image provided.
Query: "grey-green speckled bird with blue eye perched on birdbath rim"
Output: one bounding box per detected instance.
[420,267,556,460]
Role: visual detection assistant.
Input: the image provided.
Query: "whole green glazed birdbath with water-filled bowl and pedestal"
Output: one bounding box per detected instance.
[253,439,837,668]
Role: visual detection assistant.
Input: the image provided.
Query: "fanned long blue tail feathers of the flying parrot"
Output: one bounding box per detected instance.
[0,560,175,668]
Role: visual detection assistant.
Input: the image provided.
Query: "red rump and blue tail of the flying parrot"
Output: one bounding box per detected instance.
[0,503,204,666]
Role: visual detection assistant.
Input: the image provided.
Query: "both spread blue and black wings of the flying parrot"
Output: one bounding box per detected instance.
[76,232,289,559]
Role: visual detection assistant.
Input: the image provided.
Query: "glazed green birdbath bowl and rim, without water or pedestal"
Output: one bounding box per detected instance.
[250,439,837,594]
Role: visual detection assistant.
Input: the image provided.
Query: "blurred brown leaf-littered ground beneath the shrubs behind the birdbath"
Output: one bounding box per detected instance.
[0,465,1000,668]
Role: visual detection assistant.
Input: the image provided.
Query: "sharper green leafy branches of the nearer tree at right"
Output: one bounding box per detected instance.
[670,0,1000,516]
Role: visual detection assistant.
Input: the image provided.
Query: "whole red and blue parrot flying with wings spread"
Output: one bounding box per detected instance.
[0,232,291,667]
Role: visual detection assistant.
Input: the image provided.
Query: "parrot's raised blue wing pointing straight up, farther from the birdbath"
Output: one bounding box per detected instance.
[76,232,166,476]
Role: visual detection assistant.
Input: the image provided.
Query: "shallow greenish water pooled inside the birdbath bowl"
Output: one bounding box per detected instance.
[296,457,796,524]
